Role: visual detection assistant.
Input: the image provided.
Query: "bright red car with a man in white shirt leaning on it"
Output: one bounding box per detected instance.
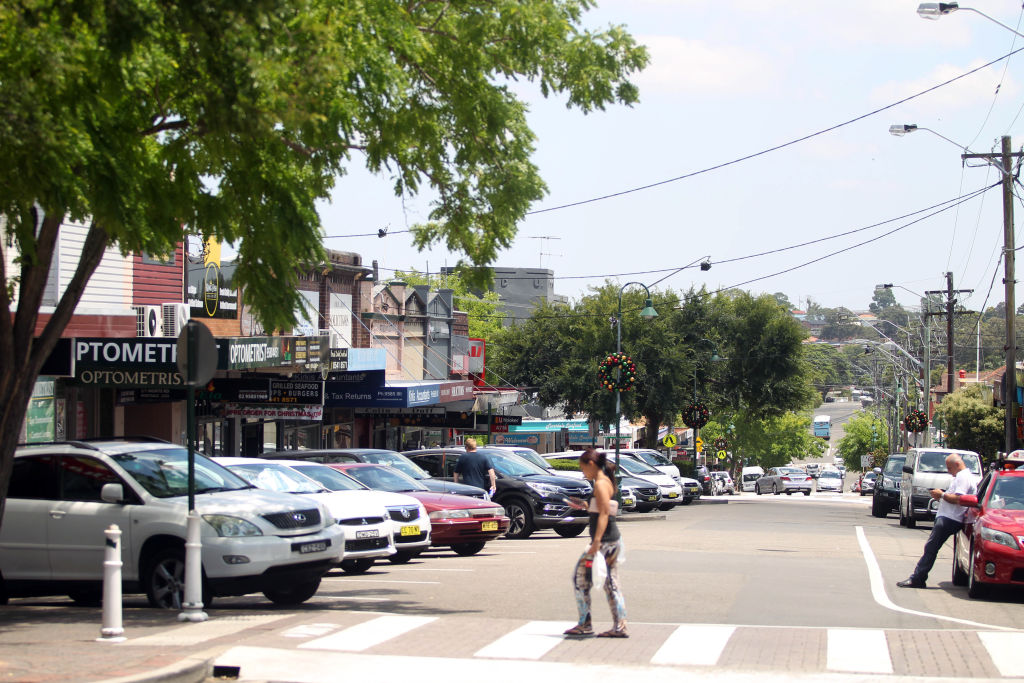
[953,451,1024,598]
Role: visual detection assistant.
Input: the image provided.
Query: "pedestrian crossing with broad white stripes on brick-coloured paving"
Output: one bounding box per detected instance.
[190,612,1024,681]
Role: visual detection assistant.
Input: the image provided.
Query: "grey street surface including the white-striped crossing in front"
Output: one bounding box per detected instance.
[167,493,1024,683]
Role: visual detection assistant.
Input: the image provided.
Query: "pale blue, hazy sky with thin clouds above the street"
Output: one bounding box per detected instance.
[311,0,1024,310]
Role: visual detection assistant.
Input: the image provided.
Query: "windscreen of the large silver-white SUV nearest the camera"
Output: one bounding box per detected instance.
[111,447,251,498]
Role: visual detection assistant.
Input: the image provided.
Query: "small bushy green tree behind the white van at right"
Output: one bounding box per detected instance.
[934,384,1006,460]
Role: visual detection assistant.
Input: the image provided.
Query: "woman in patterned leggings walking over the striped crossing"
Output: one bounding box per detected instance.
[565,447,629,638]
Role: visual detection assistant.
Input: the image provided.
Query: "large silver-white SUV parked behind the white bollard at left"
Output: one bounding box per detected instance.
[0,439,345,609]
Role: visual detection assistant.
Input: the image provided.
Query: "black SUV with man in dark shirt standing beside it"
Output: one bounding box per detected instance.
[403,447,593,539]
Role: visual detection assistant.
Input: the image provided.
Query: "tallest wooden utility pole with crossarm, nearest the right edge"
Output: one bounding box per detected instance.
[961,135,1024,453]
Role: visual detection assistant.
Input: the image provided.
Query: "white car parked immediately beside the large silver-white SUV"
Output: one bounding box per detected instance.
[214,457,407,573]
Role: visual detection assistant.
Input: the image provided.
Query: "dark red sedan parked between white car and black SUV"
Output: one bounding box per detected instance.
[328,463,509,555]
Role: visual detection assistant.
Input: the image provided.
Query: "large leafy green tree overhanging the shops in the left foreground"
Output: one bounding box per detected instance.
[0,0,647,516]
